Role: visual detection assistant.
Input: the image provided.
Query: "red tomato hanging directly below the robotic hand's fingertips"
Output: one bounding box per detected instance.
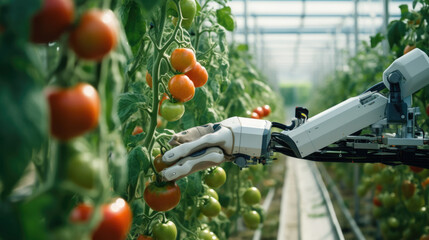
[143,182,180,212]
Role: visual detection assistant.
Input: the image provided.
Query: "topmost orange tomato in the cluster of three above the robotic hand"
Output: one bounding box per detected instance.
[170,48,197,73]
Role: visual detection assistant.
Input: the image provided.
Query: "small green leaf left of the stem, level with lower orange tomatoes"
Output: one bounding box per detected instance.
[118,93,146,123]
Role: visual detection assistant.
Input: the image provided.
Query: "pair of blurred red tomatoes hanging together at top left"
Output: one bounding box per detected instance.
[30,0,119,61]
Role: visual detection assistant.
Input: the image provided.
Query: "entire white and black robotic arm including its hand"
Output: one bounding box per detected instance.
[161,49,429,181]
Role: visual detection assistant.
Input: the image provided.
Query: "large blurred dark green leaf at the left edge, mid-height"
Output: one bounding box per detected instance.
[0,79,48,198]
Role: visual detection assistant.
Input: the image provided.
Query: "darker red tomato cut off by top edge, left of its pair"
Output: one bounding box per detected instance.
[30,0,74,43]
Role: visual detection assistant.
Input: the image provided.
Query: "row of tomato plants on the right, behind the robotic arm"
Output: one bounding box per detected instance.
[312,0,429,240]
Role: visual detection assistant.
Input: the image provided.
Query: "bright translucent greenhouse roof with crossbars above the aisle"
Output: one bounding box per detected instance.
[228,0,412,84]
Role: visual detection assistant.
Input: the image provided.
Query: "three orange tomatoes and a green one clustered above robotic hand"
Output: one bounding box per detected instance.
[146,48,208,121]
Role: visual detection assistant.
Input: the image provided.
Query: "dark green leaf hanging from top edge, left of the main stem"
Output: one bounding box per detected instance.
[123,1,146,48]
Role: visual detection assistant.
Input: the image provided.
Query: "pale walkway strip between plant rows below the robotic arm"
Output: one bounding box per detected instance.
[277,158,344,240]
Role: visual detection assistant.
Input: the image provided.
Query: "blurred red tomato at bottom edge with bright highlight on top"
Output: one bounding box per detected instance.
[92,198,133,240]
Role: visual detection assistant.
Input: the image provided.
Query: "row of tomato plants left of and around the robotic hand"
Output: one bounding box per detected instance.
[0,0,284,240]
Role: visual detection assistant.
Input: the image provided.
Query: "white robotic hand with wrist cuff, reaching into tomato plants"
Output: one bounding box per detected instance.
[161,117,271,181]
